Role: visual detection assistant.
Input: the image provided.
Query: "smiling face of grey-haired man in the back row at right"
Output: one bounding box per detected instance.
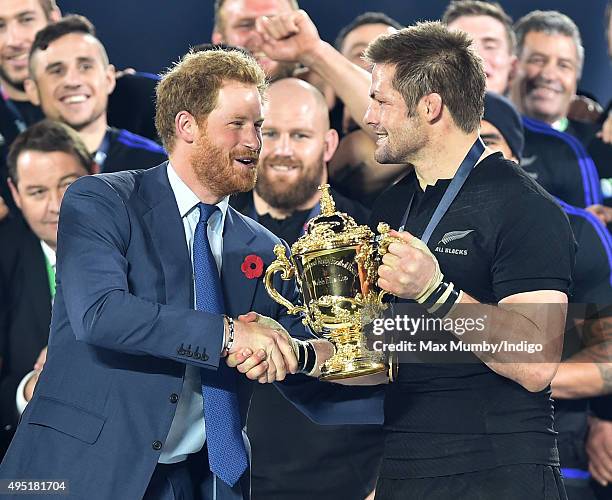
[512,32,579,124]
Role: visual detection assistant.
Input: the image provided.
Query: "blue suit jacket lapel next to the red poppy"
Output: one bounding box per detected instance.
[221,206,260,317]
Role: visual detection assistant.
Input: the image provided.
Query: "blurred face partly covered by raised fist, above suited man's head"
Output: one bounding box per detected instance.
[212,0,293,76]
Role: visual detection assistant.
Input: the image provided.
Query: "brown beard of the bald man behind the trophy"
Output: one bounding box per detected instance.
[255,153,325,211]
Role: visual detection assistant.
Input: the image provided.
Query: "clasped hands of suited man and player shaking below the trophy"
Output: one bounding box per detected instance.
[226,312,335,384]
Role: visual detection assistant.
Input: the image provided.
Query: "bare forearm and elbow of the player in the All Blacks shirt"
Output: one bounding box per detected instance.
[447,293,565,392]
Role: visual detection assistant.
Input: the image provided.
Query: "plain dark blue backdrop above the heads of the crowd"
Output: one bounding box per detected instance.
[58,0,612,105]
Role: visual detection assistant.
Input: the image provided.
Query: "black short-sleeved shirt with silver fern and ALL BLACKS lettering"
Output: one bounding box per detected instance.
[370,153,575,479]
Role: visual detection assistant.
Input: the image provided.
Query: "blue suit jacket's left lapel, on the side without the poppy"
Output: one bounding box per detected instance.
[139,163,193,308]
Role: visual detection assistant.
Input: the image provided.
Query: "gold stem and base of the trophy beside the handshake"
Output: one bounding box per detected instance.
[320,328,387,380]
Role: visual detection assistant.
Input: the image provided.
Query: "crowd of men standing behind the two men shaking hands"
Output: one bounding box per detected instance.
[0,0,612,499]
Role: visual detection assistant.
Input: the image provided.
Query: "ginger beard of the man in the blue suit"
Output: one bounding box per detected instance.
[191,134,259,197]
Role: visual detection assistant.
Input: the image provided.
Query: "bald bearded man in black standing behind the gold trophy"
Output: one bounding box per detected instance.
[230,78,382,500]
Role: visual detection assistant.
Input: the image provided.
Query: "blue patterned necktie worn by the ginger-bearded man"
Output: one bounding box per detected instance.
[193,203,248,486]
